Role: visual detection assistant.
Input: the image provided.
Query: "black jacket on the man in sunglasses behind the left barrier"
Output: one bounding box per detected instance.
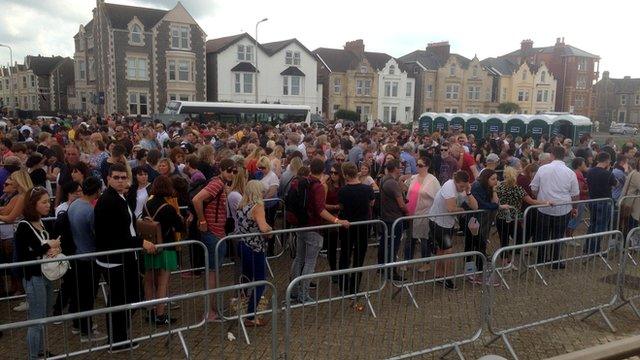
[94,187,142,264]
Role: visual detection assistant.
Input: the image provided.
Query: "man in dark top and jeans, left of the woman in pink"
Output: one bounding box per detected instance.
[378,159,408,281]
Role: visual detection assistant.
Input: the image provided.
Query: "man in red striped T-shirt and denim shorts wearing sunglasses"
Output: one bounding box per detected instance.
[192,159,238,321]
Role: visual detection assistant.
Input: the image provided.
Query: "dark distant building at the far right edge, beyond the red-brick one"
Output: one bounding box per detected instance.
[593,71,640,129]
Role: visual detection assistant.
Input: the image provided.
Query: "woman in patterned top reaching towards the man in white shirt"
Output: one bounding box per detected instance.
[498,166,549,270]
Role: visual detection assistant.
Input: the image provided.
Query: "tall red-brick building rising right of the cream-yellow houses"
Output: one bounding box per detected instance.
[499,38,600,117]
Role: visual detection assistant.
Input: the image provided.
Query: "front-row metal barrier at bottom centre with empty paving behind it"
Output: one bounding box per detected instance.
[284,252,486,359]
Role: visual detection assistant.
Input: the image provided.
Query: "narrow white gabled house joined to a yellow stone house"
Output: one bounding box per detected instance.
[378,58,415,124]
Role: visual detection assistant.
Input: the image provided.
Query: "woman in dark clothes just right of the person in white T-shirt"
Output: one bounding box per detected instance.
[464,169,510,286]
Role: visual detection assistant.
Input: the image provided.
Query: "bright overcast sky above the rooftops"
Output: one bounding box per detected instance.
[0,0,640,77]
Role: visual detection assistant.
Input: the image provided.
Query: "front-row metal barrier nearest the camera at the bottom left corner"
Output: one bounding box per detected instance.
[0,281,278,359]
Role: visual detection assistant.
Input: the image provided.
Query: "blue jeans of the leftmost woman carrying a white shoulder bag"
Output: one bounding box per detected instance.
[22,276,53,360]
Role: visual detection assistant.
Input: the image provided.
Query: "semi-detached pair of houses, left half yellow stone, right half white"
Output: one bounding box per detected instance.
[314,40,415,123]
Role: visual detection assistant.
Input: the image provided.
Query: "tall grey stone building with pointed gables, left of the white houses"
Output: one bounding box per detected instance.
[74,0,206,116]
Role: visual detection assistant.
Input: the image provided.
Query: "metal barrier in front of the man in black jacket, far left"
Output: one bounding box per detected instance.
[0,240,209,356]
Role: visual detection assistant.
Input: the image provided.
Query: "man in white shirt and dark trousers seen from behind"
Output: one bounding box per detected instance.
[530,146,580,269]
